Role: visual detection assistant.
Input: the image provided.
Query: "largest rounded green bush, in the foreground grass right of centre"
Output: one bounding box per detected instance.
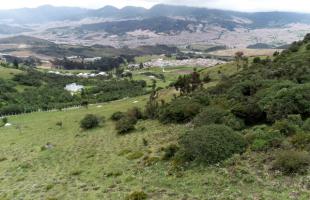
[178,125,246,164]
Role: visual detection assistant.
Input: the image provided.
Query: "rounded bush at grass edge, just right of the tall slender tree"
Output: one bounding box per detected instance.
[159,97,202,123]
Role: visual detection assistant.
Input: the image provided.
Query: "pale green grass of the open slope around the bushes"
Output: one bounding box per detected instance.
[0,64,310,200]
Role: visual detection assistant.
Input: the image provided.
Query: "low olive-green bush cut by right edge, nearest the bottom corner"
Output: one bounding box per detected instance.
[273,151,310,175]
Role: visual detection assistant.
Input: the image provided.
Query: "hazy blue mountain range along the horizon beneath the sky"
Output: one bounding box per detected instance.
[0,5,310,28]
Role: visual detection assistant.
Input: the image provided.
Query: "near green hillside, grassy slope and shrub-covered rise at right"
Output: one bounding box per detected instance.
[0,35,310,200]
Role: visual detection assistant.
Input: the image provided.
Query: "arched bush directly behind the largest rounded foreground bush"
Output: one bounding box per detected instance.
[193,107,244,130]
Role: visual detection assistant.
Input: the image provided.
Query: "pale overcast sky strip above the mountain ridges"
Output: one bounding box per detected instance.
[0,0,310,12]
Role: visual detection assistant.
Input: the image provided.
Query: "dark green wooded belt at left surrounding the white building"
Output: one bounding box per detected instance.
[0,69,146,115]
